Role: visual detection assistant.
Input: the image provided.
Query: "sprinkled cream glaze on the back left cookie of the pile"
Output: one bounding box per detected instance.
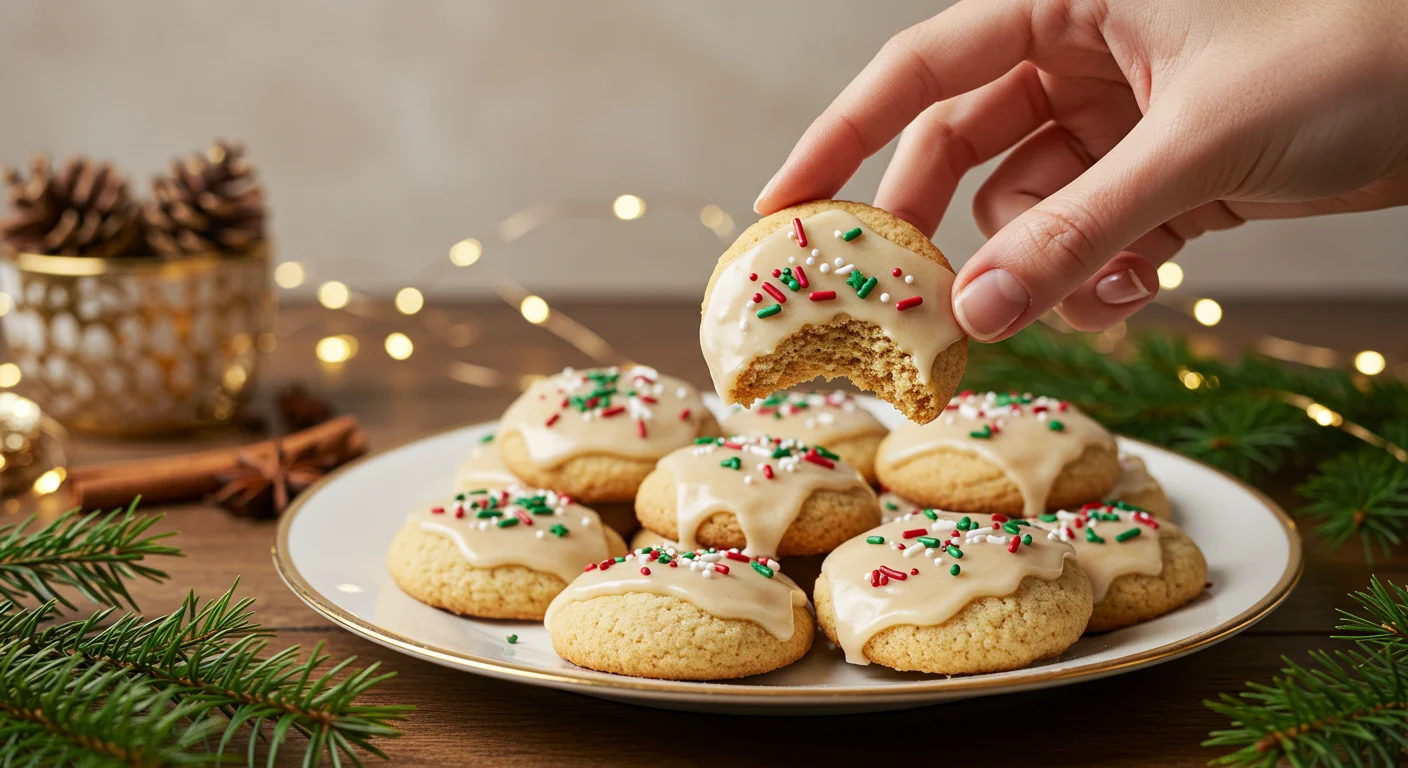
[498,365,708,468]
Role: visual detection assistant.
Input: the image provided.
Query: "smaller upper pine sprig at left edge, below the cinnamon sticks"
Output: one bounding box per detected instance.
[0,500,180,610]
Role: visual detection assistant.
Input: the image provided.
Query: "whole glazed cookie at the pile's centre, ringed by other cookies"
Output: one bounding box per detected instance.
[635,437,880,557]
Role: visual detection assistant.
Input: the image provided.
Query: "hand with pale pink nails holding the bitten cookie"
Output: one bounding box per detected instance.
[755,0,1408,341]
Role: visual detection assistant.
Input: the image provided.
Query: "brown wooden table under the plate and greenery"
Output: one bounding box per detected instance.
[60,302,1408,767]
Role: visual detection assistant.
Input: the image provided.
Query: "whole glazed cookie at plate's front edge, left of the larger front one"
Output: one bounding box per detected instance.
[545,547,814,681]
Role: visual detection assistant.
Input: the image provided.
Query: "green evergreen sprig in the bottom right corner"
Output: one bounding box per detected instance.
[1204,576,1408,767]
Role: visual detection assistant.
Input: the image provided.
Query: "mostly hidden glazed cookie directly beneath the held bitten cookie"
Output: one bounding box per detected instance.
[724,392,890,485]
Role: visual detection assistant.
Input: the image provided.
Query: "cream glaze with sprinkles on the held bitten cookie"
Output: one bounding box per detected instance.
[700,210,963,403]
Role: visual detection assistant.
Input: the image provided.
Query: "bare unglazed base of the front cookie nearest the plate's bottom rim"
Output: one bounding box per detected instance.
[552,593,814,681]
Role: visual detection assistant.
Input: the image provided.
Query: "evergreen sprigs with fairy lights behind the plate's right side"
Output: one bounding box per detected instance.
[964,328,1408,559]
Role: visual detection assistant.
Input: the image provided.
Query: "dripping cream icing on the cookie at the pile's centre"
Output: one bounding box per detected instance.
[659,437,874,554]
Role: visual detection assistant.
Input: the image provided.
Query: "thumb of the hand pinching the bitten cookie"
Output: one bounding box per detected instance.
[953,103,1219,341]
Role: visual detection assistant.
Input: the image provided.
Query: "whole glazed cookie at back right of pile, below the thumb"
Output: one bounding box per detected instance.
[876,392,1119,517]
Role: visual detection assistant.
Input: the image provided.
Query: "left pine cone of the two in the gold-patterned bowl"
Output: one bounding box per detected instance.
[0,155,141,256]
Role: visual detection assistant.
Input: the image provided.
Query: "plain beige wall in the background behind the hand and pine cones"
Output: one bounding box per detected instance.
[0,0,1408,296]
